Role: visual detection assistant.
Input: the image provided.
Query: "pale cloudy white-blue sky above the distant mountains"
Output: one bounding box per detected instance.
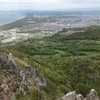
[0,0,100,10]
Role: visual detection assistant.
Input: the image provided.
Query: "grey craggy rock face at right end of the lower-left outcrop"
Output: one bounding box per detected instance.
[20,67,46,90]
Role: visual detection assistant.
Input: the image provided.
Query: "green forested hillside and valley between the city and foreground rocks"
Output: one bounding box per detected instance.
[1,26,100,100]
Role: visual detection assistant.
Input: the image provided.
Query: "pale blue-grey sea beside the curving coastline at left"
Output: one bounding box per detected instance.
[0,12,25,26]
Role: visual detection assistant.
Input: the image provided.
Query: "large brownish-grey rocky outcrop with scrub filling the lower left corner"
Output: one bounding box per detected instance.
[0,52,46,100]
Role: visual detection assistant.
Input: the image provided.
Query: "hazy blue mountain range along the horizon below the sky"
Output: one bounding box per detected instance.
[0,8,100,14]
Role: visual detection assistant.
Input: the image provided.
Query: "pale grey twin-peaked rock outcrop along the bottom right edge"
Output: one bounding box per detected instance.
[57,89,99,100]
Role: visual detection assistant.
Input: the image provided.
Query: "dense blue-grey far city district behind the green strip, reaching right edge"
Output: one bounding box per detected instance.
[19,14,100,31]
